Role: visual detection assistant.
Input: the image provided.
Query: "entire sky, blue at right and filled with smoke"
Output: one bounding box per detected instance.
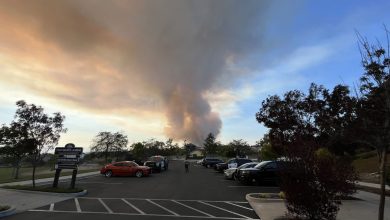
[0,0,390,151]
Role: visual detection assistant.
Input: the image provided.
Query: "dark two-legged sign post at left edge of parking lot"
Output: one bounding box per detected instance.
[53,143,83,189]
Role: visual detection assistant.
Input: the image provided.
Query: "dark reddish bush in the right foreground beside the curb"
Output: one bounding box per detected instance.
[281,148,357,220]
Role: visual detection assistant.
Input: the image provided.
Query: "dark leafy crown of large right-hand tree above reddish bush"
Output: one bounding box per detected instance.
[256,84,357,155]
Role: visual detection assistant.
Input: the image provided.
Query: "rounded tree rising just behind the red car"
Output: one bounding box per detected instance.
[91,131,128,163]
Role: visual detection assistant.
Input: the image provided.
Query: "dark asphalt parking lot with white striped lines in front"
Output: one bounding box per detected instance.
[6,161,278,220]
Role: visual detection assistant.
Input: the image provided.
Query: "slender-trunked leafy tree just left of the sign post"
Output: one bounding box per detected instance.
[12,100,67,187]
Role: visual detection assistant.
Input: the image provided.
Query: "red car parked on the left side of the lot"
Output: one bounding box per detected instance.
[100,161,151,177]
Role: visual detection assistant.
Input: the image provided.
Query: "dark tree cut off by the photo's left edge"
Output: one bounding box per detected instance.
[0,123,34,179]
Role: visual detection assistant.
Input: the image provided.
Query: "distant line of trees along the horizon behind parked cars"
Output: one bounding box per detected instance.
[89,131,257,162]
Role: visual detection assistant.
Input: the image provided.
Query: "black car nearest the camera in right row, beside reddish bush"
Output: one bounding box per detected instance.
[237,161,284,185]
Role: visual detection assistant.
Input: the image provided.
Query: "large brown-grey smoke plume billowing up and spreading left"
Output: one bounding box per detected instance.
[0,0,274,143]
